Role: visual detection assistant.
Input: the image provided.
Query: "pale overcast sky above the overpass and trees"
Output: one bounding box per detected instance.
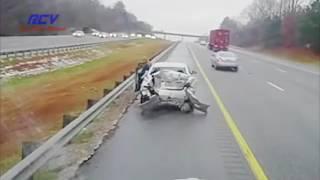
[100,0,252,34]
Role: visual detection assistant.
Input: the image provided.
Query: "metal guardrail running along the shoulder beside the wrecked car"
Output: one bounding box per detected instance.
[0,43,177,180]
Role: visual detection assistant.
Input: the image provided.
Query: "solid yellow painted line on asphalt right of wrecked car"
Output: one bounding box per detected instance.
[188,44,268,180]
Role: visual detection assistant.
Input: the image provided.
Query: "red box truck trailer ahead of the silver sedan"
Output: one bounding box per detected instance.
[208,29,230,52]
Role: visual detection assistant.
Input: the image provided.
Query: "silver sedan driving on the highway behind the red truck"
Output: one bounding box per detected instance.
[211,51,238,72]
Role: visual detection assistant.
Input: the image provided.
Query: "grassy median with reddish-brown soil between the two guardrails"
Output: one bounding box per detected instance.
[0,40,169,174]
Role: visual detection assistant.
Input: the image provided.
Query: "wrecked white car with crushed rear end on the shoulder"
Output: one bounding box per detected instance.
[136,62,209,113]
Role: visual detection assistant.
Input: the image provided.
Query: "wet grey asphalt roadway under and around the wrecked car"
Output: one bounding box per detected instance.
[79,43,320,180]
